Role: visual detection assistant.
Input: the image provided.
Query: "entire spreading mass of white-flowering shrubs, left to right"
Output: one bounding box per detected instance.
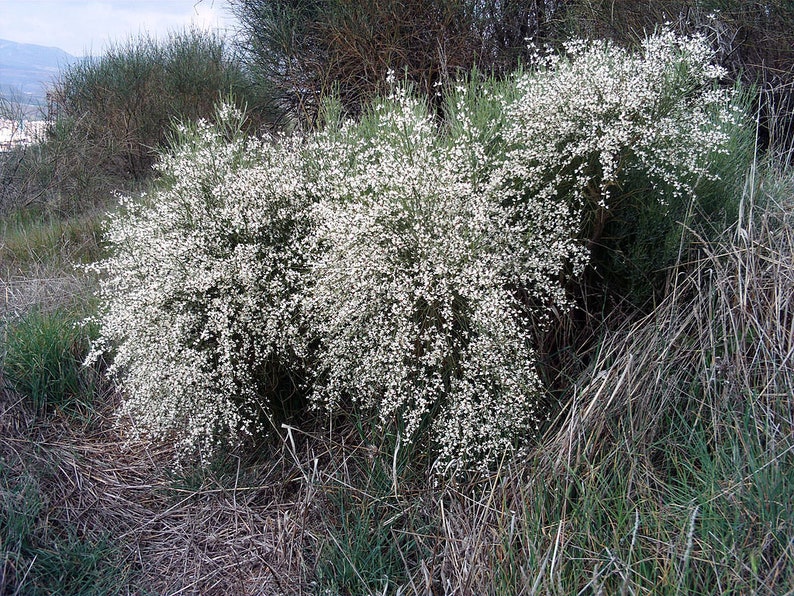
[89,34,736,469]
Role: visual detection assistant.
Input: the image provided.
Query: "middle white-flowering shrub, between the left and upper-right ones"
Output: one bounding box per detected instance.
[305,84,583,463]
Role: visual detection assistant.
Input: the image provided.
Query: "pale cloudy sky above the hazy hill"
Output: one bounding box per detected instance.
[0,0,235,56]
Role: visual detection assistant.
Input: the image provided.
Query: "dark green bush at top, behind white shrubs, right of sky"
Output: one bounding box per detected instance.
[232,0,482,123]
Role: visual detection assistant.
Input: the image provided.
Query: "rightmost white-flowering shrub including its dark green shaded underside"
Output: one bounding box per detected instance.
[500,32,752,303]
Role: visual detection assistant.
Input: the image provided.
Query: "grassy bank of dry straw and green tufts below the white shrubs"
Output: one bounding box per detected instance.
[0,170,794,595]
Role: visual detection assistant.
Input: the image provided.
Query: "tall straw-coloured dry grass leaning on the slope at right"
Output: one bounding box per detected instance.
[544,170,794,471]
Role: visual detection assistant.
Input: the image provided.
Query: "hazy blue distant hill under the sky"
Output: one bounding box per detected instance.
[0,39,80,116]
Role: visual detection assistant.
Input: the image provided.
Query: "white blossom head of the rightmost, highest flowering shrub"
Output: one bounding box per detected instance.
[503,31,741,209]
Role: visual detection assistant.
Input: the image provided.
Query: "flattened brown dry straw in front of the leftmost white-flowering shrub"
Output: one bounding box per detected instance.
[0,384,311,595]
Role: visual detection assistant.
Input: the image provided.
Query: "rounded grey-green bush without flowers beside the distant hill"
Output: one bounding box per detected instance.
[49,30,266,182]
